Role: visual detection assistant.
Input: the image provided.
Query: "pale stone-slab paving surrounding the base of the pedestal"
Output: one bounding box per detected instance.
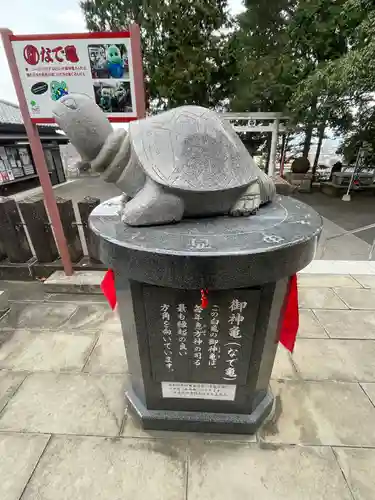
[0,274,375,500]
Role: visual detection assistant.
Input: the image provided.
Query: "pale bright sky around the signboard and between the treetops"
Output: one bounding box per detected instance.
[0,0,242,102]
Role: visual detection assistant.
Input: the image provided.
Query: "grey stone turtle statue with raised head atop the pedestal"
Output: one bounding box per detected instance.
[54,94,276,226]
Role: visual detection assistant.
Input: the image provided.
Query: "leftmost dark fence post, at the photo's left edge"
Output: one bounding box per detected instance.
[0,198,33,263]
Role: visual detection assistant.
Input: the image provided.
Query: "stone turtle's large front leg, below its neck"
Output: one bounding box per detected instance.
[122,178,185,226]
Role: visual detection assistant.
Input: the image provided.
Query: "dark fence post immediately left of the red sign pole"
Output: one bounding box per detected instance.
[18,200,59,262]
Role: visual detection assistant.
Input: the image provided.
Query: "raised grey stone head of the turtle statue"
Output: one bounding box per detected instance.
[53,93,113,161]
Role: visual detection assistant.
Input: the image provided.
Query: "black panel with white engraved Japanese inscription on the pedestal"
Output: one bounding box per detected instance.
[143,285,260,385]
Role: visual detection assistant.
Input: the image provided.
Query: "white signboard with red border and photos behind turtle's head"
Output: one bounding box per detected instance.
[11,32,137,123]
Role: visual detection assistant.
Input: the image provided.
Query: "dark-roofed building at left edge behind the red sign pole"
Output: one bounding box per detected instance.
[0,99,68,195]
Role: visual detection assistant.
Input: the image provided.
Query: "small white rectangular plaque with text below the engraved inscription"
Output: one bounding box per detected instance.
[161,382,236,401]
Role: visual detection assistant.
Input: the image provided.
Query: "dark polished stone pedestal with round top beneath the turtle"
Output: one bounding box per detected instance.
[90,196,321,433]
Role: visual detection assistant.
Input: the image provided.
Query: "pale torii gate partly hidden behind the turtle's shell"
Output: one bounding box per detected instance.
[221,113,288,175]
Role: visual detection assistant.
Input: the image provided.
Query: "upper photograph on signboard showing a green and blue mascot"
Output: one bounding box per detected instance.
[88,43,129,79]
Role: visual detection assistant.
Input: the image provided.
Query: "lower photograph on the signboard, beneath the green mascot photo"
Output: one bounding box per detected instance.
[94,80,133,113]
